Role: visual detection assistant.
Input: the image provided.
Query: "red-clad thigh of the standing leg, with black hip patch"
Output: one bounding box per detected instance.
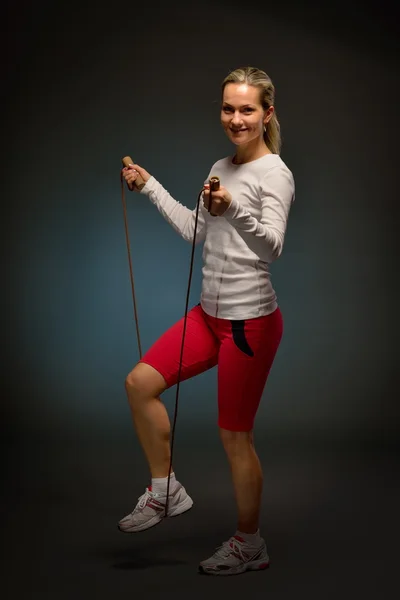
[218,308,283,431]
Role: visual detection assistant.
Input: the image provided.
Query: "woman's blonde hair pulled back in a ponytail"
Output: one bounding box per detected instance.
[222,67,282,154]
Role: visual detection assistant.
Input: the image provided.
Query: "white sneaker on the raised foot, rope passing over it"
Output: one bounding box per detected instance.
[118,483,193,533]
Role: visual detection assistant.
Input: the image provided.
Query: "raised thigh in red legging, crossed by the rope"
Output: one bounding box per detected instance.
[139,306,219,388]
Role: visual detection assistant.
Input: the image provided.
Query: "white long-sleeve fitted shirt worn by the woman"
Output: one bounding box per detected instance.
[141,154,295,320]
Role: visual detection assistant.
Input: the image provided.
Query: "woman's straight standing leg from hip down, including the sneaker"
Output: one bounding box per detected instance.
[199,309,282,575]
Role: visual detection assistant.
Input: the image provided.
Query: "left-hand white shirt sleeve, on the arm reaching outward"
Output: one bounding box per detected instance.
[140,176,206,244]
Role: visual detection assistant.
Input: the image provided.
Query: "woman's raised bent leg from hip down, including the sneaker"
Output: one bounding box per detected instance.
[118,307,219,533]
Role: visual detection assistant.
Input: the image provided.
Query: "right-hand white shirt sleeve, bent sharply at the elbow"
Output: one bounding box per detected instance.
[223,167,295,260]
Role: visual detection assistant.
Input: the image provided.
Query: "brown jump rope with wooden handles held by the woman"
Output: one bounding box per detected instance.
[121,156,220,516]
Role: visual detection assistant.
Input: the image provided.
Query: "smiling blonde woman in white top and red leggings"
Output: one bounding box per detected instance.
[119,67,294,575]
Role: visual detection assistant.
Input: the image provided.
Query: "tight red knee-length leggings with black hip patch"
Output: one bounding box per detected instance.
[140,305,283,431]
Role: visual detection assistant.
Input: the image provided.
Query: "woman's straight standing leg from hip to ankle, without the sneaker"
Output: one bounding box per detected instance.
[218,308,283,533]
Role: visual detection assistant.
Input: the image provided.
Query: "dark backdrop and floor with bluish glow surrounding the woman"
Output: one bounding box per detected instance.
[2,0,399,599]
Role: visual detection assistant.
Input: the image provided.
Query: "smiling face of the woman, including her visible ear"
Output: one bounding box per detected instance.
[221,83,274,146]
